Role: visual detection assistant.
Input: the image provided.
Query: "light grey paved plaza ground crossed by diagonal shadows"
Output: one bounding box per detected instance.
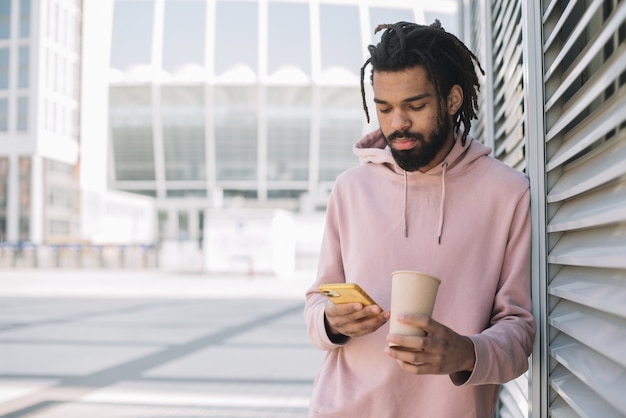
[0,270,322,418]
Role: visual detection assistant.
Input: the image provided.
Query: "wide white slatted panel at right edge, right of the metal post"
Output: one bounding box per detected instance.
[543,0,626,417]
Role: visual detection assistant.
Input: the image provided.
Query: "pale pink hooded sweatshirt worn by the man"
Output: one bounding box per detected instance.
[304,131,535,418]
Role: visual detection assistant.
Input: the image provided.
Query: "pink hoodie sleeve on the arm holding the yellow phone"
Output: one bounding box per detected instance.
[304,186,349,350]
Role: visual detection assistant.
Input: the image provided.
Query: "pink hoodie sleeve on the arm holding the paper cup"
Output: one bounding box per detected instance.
[451,190,536,385]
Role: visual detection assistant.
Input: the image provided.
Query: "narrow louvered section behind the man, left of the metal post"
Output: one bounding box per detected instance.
[467,0,529,418]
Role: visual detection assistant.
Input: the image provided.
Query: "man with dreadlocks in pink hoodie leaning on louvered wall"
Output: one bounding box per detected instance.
[304,21,535,418]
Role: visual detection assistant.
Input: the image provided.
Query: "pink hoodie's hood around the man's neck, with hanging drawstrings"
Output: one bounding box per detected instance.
[353,129,491,244]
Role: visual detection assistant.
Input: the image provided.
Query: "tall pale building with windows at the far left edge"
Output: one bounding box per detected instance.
[0,0,82,245]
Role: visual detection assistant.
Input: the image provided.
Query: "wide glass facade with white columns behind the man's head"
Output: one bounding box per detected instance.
[109,0,460,242]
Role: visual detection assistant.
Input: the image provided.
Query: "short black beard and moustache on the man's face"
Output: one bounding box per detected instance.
[383,115,451,171]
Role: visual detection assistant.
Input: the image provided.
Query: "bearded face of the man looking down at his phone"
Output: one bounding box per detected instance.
[373,66,453,172]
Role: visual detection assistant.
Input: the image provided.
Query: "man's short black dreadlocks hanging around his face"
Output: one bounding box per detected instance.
[361,20,485,145]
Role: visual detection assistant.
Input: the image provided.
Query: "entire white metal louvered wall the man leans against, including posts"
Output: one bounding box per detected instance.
[464,0,626,418]
